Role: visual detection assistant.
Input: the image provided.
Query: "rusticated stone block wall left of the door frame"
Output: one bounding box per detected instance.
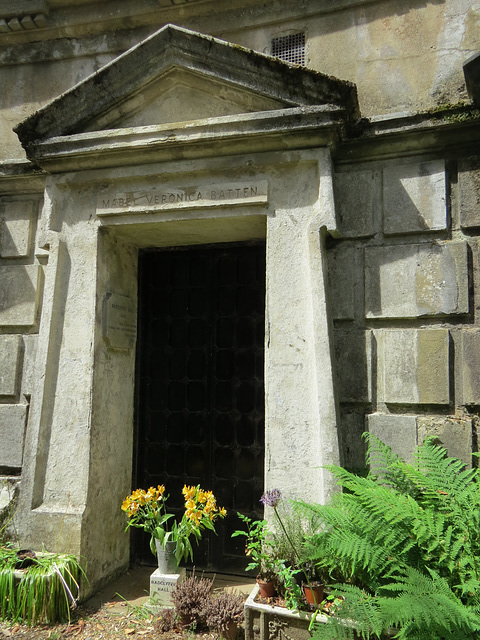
[0,195,42,475]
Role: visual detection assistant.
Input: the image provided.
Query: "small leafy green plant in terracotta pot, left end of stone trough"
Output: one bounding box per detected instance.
[232,513,276,598]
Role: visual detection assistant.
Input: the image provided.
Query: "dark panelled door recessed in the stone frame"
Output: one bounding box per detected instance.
[134,243,265,573]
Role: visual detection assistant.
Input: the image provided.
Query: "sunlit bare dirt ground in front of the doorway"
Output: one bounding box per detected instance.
[0,567,253,640]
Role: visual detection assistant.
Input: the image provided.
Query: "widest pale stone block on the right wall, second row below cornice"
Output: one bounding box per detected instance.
[365,242,468,318]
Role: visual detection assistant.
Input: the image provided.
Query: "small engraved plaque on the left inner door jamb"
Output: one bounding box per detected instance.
[103,293,137,349]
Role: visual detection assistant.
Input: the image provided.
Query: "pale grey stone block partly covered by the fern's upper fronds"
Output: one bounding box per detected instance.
[367,413,417,463]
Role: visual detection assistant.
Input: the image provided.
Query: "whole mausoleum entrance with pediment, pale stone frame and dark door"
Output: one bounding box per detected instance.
[12,25,352,588]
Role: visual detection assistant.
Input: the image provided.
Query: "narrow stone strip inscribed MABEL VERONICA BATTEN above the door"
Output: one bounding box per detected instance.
[97,180,268,216]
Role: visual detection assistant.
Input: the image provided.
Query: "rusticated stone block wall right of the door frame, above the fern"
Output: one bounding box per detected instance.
[328,156,480,468]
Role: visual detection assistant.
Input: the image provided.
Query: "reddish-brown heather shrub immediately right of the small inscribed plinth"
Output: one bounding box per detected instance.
[172,573,213,629]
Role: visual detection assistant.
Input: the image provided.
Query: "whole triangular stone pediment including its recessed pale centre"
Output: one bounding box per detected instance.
[15,25,358,148]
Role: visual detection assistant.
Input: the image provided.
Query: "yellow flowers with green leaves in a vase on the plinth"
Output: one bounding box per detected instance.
[122,484,226,573]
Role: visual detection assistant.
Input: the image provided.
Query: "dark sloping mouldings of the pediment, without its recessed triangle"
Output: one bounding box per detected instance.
[15,24,358,149]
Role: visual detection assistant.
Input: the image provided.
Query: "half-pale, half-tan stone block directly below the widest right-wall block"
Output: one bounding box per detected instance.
[376,329,450,405]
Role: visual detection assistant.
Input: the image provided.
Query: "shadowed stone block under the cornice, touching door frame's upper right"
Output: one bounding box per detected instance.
[334,170,381,238]
